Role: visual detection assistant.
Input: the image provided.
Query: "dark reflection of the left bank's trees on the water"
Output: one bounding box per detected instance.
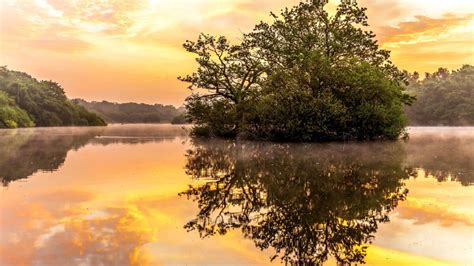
[0,125,186,186]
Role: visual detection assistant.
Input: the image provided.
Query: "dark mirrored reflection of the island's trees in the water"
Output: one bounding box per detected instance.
[182,142,411,265]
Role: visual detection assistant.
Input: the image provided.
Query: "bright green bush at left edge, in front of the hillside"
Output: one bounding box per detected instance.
[0,91,34,128]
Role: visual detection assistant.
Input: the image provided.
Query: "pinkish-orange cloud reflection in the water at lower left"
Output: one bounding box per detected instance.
[0,191,157,265]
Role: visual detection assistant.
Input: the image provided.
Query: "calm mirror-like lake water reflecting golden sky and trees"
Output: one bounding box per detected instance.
[0,125,474,265]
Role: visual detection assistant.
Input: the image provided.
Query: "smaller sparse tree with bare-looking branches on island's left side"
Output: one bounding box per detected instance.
[179,34,263,135]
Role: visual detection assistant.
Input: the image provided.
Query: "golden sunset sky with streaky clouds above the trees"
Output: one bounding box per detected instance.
[0,0,474,106]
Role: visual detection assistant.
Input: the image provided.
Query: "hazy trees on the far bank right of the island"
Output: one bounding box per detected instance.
[407,65,474,126]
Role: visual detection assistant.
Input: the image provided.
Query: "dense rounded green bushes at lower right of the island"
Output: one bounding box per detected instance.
[251,55,408,141]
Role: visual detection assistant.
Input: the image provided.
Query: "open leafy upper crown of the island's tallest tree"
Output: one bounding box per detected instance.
[246,0,403,80]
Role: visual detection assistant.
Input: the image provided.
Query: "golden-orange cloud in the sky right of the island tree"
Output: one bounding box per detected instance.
[377,14,474,72]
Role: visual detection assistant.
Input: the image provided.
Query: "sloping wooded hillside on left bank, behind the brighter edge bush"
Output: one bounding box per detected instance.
[0,67,106,127]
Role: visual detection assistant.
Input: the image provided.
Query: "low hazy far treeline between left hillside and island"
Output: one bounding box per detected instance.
[74,99,186,124]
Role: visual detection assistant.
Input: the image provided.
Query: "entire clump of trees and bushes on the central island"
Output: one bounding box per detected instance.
[181,0,412,141]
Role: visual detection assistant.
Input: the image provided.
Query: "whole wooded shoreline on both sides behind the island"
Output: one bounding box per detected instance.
[0,65,474,128]
